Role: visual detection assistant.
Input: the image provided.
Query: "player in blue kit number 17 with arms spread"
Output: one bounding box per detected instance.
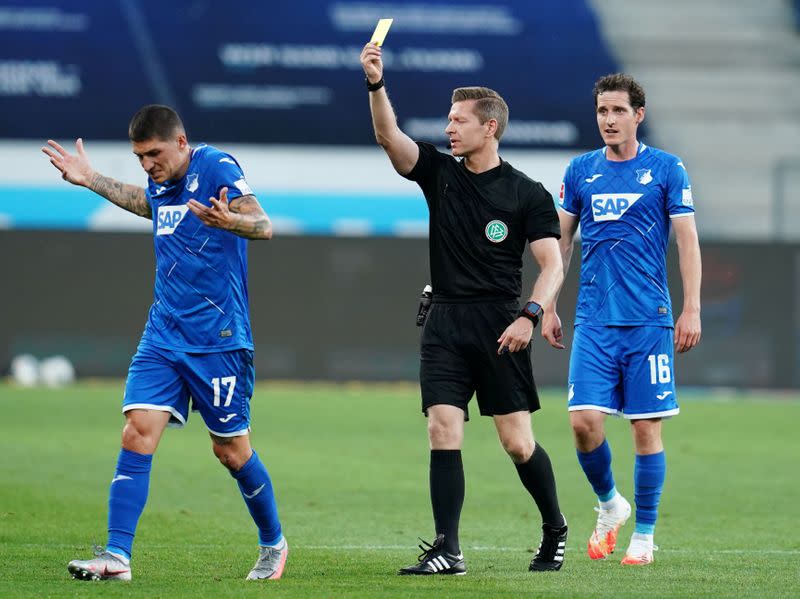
[42,105,288,580]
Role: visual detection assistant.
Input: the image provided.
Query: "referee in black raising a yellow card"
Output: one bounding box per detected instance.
[361,43,567,575]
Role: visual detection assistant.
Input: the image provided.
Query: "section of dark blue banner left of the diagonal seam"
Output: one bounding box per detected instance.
[0,0,156,139]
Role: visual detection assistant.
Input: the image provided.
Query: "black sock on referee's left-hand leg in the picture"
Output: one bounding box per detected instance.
[430,449,466,555]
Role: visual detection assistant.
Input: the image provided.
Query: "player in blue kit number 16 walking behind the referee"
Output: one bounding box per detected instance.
[542,74,701,565]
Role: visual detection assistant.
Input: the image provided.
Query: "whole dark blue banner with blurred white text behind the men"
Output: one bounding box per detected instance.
[0,0,617,149]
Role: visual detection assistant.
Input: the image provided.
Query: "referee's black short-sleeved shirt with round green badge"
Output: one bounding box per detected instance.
[406,142,561,301]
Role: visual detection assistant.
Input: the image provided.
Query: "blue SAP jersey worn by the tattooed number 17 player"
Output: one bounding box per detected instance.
[142,145,253,352]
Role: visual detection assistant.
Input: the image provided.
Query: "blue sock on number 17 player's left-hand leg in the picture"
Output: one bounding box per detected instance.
[106,449,153,559]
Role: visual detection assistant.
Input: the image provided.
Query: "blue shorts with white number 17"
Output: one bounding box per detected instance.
[122,343,255,437]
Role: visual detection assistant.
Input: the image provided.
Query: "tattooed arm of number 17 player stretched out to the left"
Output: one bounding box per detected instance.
[42,139,153,219]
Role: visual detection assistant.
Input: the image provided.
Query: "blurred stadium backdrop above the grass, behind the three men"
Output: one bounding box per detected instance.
[0,0,800,388]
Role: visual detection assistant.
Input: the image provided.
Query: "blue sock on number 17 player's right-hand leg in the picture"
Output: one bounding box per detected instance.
[231,451,282,546]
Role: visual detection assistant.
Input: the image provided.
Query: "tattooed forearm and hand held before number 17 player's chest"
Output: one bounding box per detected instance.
[186,187,272,239]
